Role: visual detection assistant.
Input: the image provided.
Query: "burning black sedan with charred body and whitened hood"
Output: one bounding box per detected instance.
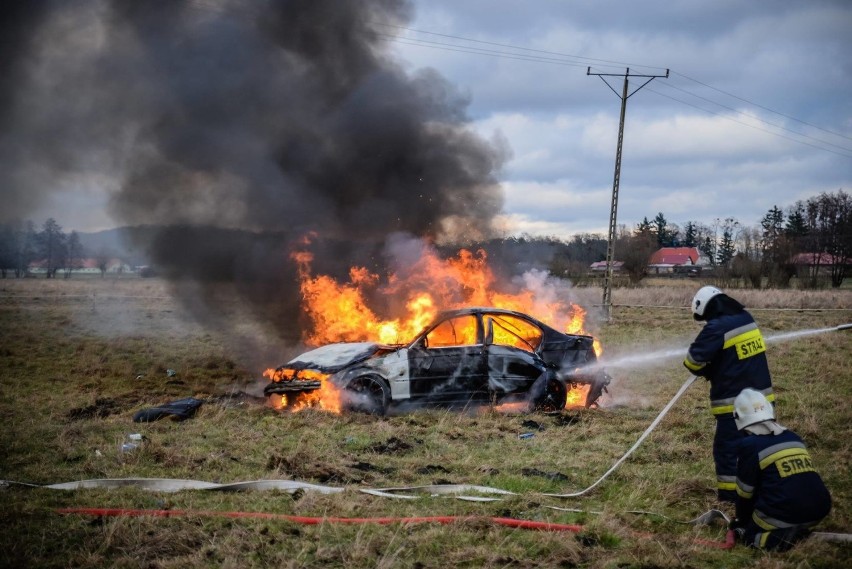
[264,307,610,414]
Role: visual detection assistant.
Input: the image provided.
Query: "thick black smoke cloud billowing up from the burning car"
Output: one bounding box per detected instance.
[0,0,508,350]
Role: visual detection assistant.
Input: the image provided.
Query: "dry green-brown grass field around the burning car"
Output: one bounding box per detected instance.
[0,279,852,568]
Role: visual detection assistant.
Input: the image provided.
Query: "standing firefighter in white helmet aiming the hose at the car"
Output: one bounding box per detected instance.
[683,286,775,502]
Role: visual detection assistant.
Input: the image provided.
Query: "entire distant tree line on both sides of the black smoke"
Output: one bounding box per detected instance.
[0,190,852,288]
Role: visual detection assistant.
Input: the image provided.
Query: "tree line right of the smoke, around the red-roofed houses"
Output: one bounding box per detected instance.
[482,190,852,288]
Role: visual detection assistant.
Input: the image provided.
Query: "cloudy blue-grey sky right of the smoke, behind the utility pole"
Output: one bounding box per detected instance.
[396,0,852,238]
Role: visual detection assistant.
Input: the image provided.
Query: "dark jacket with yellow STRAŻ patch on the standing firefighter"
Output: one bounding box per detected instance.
[683,310,775,415]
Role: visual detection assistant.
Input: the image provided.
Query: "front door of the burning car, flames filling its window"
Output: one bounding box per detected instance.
[408,314,488,405]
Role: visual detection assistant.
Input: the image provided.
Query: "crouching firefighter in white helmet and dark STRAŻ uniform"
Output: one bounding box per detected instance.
[731,389,831,551]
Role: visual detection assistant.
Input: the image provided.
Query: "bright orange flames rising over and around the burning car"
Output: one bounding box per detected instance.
[272,241,601,412]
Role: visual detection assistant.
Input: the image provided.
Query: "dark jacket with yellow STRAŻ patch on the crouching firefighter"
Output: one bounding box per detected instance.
[737,430,831,531]
